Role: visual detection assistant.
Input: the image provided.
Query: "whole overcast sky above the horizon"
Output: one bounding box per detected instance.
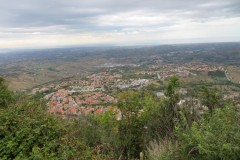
[0,0,240,49]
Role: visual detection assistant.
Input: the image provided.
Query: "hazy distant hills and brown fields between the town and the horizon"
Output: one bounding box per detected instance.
[0,43,240,90]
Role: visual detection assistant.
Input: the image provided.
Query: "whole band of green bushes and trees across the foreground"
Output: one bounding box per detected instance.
[0,77,240,160]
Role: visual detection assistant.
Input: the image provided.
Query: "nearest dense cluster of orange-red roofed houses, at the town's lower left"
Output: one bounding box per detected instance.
[44,89,117,116]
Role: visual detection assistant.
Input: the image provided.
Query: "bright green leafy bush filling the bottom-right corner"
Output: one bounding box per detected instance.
[176,107,240,160]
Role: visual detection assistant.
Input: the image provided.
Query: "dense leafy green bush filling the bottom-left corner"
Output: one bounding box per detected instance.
[0,101,94,160]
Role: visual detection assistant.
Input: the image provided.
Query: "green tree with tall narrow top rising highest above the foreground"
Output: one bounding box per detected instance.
[142,77,179,143]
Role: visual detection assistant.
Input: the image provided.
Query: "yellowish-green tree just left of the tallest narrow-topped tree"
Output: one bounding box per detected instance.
[118,91,144,159]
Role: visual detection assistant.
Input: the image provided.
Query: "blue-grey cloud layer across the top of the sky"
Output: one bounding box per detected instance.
[0,0,240,33]
